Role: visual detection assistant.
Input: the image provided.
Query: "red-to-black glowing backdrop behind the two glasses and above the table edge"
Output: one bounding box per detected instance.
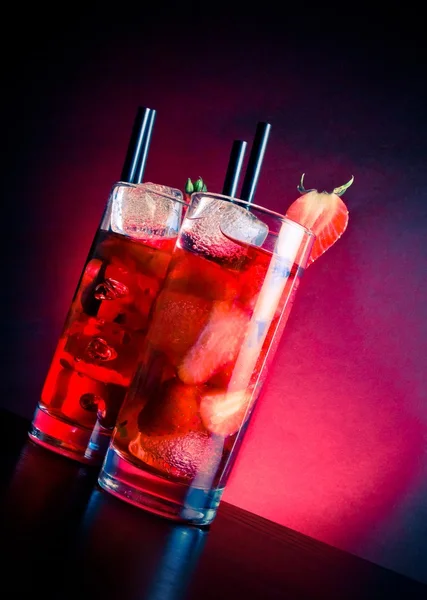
[1,5,427,582]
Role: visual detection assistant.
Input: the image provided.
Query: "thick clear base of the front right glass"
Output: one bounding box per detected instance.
[98,448,224,526]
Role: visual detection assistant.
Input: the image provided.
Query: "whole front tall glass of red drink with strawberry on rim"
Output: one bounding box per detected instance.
[98,193,314,525]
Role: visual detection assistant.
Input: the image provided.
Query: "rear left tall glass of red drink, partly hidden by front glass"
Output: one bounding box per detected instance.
[29,182,186,465]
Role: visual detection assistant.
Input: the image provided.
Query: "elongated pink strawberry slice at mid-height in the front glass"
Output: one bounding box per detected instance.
[178,302,249,385]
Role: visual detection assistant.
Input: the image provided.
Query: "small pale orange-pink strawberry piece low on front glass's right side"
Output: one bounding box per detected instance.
[200,391,250,437]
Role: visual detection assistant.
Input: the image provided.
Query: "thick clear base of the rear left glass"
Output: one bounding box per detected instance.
[28,407,111,466]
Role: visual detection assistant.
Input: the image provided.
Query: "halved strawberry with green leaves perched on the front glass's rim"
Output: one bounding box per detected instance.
[286,173,354,266]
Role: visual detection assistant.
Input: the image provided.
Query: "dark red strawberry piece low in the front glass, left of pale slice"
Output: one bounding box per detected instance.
[138,379,203,435]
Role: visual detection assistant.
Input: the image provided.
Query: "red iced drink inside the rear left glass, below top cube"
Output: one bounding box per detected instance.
[40,231,176,429]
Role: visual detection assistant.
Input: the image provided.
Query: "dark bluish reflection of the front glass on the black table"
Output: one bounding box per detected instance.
[77,489,208,600]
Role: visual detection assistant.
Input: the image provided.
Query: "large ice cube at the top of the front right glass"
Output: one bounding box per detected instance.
[183,194,269,259]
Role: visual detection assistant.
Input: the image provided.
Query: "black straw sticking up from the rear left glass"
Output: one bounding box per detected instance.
[120,106,156,183]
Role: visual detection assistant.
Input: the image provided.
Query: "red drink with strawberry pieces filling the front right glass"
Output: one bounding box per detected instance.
[113,234,302,487]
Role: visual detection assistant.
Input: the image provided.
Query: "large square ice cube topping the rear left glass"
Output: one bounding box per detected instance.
[111,183,184,239]
